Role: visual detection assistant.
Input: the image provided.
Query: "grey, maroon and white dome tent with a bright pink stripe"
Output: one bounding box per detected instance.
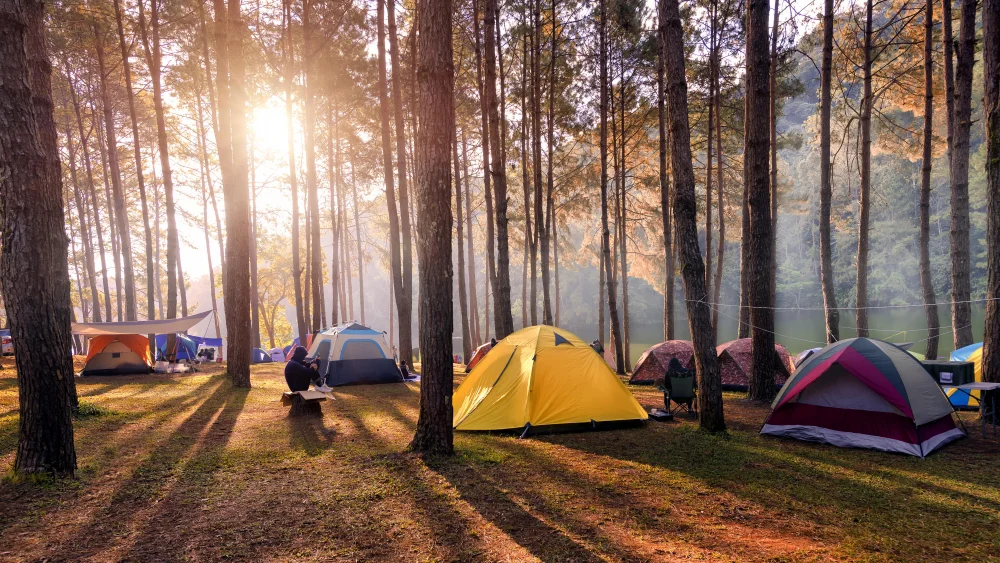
[760,338,965,457]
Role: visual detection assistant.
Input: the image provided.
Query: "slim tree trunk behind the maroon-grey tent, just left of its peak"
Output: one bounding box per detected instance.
[819,0,840,344]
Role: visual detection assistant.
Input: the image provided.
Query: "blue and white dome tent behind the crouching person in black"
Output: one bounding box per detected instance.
[308,322,403,387]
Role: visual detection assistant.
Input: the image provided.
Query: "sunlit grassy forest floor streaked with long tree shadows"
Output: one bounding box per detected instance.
[0,365,1000,562]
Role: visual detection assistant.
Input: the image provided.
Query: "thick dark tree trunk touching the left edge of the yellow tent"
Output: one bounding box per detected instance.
[410,0,454,455]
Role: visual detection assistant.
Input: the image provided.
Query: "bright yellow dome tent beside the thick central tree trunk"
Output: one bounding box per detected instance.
[452,326,647,430]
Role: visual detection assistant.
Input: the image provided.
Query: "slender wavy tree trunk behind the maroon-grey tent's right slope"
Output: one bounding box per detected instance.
[920,0,941,360]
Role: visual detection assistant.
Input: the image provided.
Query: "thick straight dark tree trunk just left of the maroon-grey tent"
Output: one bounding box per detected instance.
[744,0,774,401]
